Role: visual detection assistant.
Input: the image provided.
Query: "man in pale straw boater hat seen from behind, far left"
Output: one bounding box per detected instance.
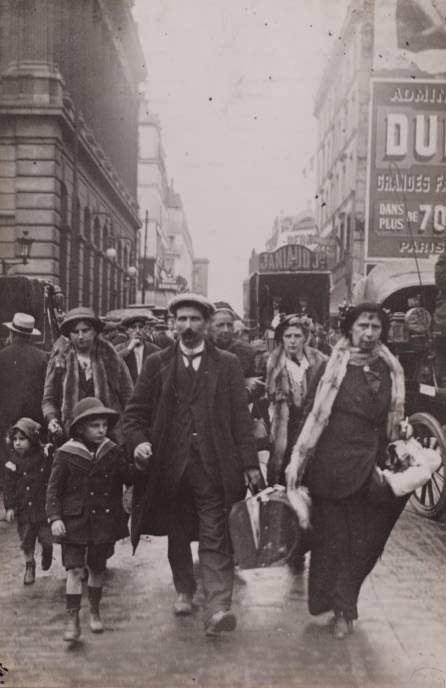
[0,313,48,472]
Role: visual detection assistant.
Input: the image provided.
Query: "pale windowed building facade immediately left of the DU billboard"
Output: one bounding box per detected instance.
[314,0,373,302]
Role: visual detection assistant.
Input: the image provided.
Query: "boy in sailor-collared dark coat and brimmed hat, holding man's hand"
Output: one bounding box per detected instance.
[46,397,145,641]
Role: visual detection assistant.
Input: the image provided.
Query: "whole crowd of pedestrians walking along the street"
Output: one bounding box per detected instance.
[0,294,407,641]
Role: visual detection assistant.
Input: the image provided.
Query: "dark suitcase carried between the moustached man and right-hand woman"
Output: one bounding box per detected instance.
[229,488,301,569]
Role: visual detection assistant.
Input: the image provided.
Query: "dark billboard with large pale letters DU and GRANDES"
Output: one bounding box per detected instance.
[366,79,446,261]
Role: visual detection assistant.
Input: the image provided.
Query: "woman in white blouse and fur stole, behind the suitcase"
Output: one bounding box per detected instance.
[266,315,327,485]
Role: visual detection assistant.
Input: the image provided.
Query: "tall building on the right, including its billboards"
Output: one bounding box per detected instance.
[315,0,446,307]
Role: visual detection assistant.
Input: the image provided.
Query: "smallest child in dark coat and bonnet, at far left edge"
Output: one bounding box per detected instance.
[3,418,53,585]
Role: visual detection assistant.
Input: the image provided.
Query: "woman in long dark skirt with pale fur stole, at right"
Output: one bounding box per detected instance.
[287,302,408,639]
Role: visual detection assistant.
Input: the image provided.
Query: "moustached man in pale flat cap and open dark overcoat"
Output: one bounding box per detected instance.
[124,294,262,636]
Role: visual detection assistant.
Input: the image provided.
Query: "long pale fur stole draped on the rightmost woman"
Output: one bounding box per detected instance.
[286,337,405,491]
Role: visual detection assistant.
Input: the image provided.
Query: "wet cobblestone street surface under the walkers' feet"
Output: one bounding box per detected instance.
[0,506,446,688]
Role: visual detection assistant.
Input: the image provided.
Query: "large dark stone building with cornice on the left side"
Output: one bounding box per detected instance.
[0,0,146,313]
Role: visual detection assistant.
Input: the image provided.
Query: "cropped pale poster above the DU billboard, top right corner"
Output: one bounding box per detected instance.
[373,0,446,74]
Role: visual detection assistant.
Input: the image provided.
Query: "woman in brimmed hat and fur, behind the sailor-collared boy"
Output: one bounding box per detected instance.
[42,307,133,444]
